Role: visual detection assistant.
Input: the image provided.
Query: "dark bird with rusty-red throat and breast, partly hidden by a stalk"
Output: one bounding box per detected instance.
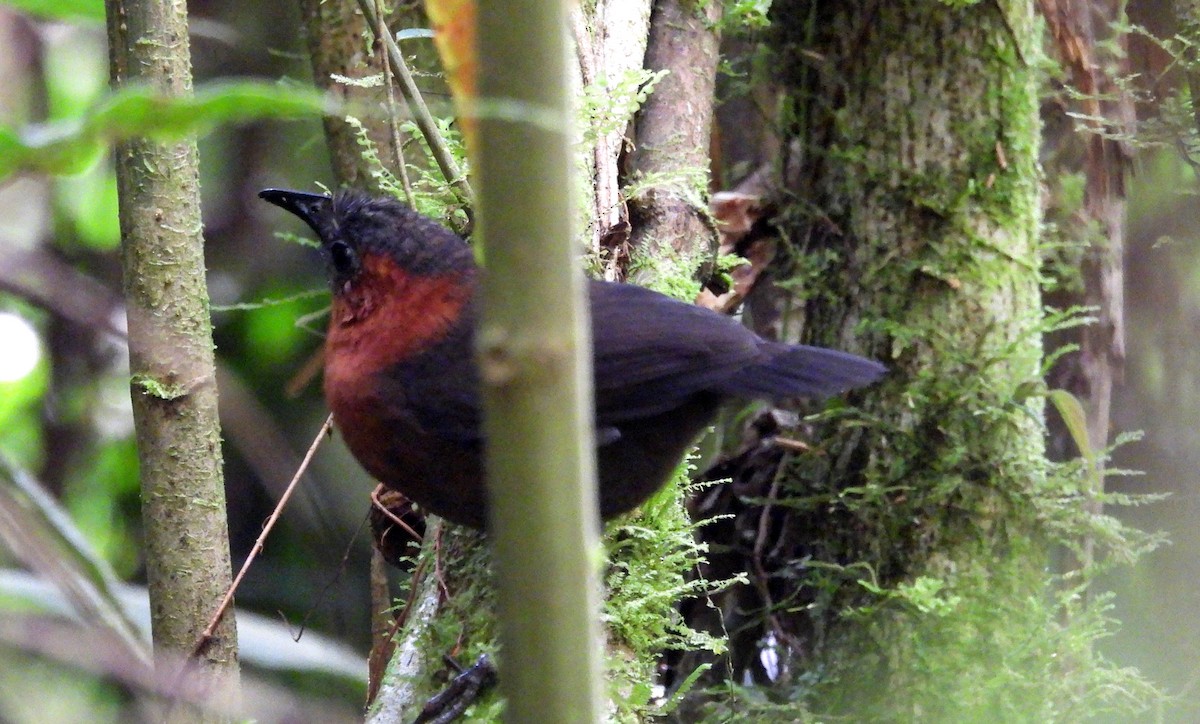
[259,189,886,529]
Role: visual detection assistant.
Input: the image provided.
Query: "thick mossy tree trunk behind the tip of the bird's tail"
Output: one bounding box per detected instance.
[696,0,1057,720]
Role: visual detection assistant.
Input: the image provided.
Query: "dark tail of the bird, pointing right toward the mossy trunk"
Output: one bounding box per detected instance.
[718,342,887,400]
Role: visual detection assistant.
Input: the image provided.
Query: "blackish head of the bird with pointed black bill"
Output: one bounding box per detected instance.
[258,189,474,295]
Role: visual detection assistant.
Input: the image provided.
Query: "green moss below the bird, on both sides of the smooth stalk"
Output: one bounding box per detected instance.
[374,463,733,722]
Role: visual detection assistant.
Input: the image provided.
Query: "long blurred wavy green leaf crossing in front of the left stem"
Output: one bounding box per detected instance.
[0,82,332,179]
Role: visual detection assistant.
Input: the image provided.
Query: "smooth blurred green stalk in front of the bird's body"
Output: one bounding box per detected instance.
[479,0,602,722]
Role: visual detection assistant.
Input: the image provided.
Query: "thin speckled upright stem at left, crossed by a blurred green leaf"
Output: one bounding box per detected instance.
[106,0,238,696]
